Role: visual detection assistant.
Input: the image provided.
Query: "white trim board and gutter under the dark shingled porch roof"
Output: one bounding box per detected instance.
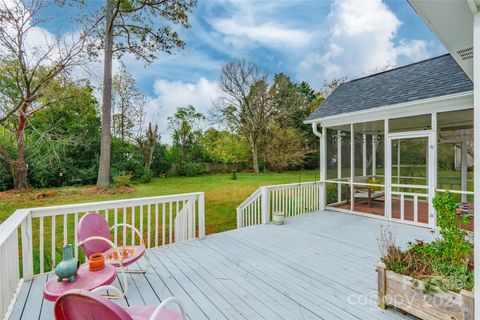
[304,91,473,127]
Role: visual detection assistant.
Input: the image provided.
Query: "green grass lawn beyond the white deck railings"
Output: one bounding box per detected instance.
[0,170,318,234]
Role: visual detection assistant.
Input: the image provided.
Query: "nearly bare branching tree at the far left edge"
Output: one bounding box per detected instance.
[0,0,84,189]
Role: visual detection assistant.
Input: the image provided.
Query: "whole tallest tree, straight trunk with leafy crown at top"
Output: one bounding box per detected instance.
[76,0,196,188]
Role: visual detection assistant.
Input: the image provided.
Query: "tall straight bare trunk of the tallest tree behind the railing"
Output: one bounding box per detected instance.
[97,0,114,189]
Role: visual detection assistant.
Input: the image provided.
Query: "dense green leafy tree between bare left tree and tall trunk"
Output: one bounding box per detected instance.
[26,80,100,187]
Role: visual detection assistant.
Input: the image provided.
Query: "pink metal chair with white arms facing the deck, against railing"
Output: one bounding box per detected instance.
[77,212,150,273]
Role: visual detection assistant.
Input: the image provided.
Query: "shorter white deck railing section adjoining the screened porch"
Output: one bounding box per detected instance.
[237,182,321,228]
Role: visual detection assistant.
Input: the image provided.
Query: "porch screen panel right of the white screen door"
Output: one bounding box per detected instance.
[437,109,474,231]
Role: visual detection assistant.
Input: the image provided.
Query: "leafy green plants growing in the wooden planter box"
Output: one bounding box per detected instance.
[379,192,474,293]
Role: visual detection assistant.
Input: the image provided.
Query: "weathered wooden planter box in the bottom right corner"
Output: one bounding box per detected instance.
[377,263,475,320]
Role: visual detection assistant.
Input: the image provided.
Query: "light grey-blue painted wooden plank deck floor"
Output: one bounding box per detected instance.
[10,211,432,320]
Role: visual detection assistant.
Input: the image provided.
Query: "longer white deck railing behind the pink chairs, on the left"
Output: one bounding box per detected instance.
[0,192,205,318]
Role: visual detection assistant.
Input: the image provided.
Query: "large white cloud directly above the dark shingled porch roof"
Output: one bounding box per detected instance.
[297,0,429,88]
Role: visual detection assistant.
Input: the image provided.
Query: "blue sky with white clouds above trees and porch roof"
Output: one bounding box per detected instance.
[35,0,446,139]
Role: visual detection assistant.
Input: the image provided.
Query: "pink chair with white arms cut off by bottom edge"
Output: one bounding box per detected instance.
[54,286,186,320]
